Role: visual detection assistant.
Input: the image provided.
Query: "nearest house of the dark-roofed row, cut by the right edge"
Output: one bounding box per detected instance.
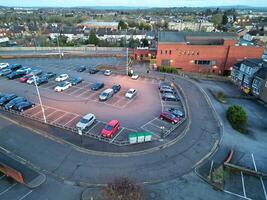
[252,66,267,103]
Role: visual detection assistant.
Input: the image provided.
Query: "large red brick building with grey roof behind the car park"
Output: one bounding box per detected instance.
[157,32,264,74]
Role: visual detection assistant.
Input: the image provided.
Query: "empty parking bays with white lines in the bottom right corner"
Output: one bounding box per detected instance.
[224,152,267,200]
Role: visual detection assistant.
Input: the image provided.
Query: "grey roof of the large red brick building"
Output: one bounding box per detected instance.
[158,31,237,43]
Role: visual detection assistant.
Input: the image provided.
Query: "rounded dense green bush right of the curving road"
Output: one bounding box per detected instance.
[226,105,247,133]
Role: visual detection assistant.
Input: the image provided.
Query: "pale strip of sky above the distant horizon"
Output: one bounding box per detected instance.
[0,0,267,7]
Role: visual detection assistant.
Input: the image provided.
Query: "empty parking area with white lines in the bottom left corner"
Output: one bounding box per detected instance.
[0,172,33,200]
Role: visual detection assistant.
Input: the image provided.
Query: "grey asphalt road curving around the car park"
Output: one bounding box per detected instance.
[0,75,219,184]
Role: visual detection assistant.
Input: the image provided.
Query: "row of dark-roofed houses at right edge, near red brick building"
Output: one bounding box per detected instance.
[231,56,267,103]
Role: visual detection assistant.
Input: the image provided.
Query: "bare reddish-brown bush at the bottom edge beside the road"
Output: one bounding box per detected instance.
[102,178,144,200]
